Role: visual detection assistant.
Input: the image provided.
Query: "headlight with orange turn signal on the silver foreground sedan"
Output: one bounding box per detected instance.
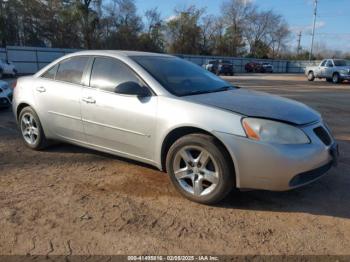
[242,118,310,144]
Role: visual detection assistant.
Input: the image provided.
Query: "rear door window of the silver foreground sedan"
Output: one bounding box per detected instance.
[55,56,89,84]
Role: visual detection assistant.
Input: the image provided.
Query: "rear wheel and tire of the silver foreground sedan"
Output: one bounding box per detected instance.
[18,106,48,150]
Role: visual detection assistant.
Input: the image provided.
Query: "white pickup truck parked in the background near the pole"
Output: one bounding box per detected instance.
[305,59,350,84]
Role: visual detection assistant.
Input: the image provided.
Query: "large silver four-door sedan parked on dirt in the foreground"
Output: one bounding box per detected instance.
[13,51,338,204]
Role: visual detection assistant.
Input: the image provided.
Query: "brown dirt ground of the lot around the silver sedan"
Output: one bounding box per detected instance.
[0,74,350,255]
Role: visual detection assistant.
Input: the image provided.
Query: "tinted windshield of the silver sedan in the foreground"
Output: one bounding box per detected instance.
[131,56,234,96]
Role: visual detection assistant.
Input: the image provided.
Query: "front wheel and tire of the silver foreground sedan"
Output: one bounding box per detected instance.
[166,134,235,205]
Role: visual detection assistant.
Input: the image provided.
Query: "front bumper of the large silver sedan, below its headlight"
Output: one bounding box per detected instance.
[216,123,338,191]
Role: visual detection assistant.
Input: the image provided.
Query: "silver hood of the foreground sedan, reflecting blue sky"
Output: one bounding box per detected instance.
[183,88,321,125]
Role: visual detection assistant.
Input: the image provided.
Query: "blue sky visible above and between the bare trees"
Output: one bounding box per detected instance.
[136,0,350,51]
